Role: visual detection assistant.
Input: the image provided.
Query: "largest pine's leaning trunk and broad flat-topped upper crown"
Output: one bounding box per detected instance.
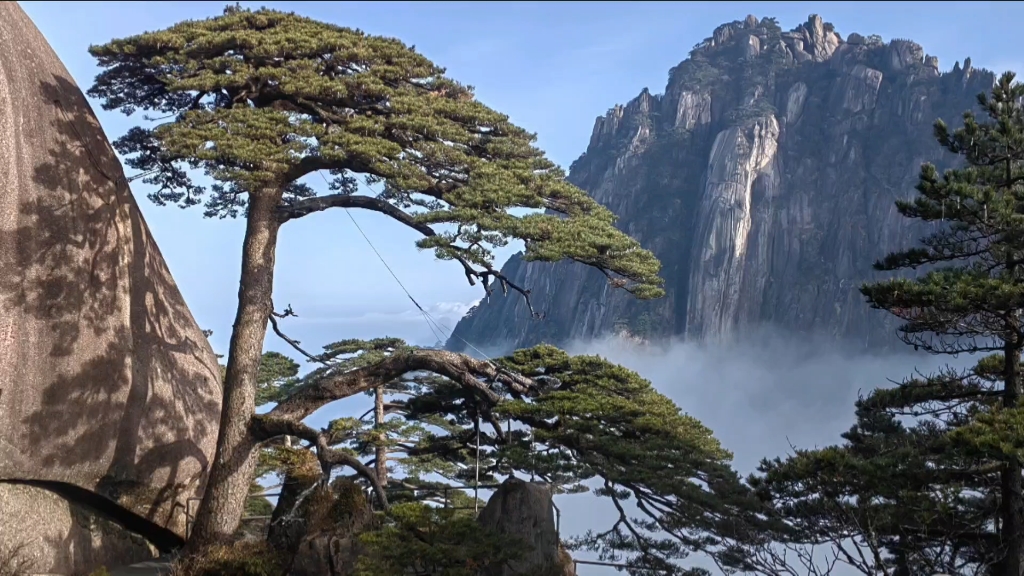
[89,6,663,548]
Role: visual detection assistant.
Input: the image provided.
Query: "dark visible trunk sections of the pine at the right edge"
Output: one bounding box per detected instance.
[999,342,1024,576]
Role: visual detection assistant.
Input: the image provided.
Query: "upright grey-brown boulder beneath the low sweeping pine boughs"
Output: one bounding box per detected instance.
[477,478,573,576]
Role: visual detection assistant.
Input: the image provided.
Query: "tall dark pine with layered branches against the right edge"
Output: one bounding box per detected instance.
[861,73,1024,576]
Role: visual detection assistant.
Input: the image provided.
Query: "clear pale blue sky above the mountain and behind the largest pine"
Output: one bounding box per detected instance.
[22,1,1024,351]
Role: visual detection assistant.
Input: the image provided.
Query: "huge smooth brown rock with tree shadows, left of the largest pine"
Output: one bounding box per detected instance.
[0,2,220,573]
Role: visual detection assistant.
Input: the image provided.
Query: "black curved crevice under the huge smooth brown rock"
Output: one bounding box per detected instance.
[0,479,185,554]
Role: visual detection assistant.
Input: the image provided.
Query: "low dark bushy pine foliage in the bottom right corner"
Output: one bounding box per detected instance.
[750,387,998,576]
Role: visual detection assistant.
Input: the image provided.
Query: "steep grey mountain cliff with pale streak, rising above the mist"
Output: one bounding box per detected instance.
[449,15,994,349]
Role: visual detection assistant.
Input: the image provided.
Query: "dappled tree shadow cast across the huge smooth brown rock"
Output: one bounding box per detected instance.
[0,76,220,541]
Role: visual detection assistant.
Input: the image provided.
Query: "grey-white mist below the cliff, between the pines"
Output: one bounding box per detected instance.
[544,331,967,576]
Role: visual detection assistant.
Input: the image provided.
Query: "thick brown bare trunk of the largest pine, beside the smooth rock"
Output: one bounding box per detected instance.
[187,191,281,551]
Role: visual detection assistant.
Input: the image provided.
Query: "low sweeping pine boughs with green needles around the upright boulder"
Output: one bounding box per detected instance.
[257,338,761,575]
